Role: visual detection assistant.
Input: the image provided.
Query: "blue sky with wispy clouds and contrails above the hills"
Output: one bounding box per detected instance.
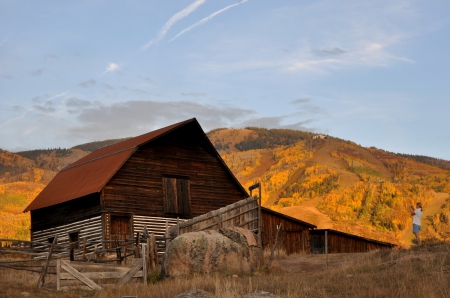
[0,0,450,160]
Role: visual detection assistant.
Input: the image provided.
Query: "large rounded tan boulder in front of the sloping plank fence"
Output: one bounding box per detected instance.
[164,227,262,277]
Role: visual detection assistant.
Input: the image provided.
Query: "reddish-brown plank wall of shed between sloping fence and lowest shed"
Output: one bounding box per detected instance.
[261,209,311,254]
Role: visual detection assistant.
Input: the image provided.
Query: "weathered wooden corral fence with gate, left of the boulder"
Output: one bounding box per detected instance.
[0,229,158,290]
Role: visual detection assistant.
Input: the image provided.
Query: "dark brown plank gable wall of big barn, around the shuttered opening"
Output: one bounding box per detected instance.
[102,125,246,218]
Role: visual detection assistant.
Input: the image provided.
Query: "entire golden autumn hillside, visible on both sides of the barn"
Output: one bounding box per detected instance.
[0,127,450,246]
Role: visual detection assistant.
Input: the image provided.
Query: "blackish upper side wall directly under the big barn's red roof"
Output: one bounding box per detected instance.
[30,193,101,232]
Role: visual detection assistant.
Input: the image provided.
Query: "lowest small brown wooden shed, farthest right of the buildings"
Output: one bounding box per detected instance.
[309,229,396,254]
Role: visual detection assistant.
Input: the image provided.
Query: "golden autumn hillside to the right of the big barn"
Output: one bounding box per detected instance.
[210,128,450,246]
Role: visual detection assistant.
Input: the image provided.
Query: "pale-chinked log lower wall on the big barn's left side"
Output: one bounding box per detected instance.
[32,216,102,252]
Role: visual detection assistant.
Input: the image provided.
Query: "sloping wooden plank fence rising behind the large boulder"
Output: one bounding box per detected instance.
[167,197,261,243]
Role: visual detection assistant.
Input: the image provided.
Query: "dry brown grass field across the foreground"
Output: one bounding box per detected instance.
[0,243,450,298]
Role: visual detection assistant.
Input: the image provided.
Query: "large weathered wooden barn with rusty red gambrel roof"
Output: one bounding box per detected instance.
[24,118,249,249]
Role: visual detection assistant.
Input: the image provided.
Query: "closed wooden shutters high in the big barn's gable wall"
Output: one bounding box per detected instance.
[163,176,191,215]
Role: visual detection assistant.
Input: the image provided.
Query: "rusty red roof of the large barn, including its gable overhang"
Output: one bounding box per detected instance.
[24,118,247,212]
